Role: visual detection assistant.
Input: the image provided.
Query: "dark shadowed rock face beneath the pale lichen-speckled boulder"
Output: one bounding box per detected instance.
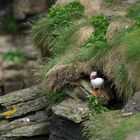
[49,116,85,140]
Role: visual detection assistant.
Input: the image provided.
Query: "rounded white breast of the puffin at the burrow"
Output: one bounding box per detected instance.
[91,78,104,88]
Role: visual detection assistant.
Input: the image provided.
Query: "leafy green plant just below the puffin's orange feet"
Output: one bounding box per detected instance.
[87,95,107,114]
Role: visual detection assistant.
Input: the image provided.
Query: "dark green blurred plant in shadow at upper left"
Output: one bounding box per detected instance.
[2,14,21,33]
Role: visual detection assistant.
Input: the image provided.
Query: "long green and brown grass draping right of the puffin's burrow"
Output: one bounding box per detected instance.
[106,26,140,101]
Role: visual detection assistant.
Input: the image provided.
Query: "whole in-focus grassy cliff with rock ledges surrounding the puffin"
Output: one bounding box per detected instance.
[0,0,140,140]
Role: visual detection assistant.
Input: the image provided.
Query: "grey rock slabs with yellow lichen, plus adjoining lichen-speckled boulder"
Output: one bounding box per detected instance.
[0,85,89,140]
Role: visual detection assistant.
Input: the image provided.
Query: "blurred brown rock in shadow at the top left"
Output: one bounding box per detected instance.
[13,0,47,19]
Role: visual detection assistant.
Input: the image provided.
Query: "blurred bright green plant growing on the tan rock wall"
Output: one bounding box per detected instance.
[4,51,27,64]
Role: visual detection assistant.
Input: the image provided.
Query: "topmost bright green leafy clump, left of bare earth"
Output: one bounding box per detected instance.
[48,1,84,28]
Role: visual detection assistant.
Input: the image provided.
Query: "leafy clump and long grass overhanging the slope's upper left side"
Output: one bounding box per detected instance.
[31,1,88,80]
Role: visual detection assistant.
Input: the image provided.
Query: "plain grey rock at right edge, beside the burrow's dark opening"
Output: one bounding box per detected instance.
[122,91,140,112]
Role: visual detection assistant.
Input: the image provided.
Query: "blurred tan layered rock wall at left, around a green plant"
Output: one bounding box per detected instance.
[0,35,39,94]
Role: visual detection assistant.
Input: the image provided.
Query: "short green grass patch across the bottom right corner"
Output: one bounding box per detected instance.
[83,111,140,140]
